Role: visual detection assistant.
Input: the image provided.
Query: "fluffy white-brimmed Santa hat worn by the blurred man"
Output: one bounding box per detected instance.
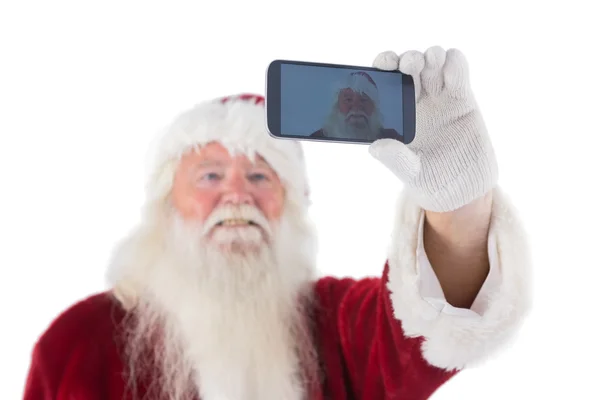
[146,94,309,211]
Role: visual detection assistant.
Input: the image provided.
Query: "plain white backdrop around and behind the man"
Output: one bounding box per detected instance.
[0,0,600,400]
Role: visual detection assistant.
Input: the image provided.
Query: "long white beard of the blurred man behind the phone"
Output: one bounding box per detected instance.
[113,200,317,400]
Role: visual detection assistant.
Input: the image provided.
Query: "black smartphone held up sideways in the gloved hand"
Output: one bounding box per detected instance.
[265,60,416,144]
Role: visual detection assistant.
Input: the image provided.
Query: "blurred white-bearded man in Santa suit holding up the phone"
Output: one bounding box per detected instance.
[25,47,529,400]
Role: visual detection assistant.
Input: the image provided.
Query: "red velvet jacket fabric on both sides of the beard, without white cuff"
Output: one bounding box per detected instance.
[24,260,456,400]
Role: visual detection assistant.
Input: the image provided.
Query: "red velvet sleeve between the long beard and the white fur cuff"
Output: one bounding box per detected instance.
[316,265,456,400]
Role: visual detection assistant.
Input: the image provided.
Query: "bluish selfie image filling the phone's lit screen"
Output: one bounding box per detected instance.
[281,64,403,141]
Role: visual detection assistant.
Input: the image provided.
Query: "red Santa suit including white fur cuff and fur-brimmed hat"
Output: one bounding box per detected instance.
[24,96,530,400]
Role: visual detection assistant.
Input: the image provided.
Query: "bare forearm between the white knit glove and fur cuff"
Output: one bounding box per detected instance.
[423,192,492,308]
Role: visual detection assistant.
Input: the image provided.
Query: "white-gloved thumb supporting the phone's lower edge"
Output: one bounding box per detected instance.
[369,139,421,181]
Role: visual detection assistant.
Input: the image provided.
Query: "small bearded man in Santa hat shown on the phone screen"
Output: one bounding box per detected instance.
[310,71,402,141]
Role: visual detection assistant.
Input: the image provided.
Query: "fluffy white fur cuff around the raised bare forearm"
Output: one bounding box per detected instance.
[388,189,531,370]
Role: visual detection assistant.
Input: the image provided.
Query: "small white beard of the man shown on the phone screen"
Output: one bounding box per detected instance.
[323,103,383,140]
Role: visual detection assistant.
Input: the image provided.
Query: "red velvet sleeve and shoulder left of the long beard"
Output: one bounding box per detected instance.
[23,294,126,400]
